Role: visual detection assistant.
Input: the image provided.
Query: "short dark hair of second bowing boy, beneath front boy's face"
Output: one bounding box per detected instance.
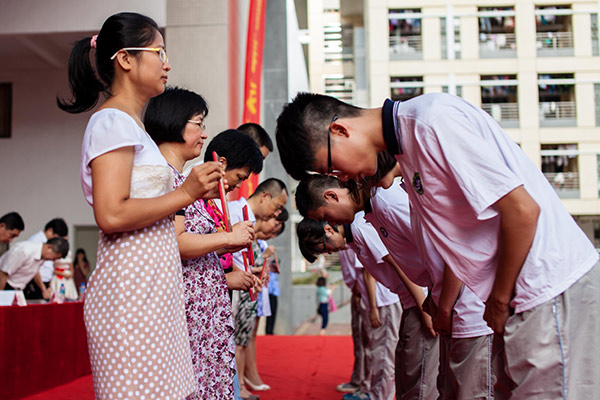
[296,174,360,217]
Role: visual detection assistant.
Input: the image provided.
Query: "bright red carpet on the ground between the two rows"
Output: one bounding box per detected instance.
[26,336,354,400]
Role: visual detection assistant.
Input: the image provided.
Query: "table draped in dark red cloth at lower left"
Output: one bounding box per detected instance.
[0,302,91,400]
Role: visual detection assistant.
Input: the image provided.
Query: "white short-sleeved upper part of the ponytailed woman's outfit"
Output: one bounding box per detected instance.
[80,108,167,205]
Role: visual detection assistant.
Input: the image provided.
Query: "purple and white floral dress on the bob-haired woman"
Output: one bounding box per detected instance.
[171,167,235,400]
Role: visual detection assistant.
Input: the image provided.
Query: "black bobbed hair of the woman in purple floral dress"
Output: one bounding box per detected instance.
[144,87,208,144]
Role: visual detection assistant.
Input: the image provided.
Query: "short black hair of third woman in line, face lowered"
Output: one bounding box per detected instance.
[204,129,263,174]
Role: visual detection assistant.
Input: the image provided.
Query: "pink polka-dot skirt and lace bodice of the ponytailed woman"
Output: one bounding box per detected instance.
[84,166,195,400]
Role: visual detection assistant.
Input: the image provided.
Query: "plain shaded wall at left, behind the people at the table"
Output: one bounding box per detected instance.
[0,68,95,244]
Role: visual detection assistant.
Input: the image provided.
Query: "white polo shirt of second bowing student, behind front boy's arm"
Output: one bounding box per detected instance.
[365,184,493,338]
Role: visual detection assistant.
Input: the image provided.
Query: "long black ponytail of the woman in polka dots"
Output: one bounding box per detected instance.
[56,37,106,114]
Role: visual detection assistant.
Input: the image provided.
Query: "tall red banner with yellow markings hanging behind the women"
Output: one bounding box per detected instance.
[237,0,267,199]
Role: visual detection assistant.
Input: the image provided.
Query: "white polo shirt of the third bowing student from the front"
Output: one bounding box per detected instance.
[344,211,398,309]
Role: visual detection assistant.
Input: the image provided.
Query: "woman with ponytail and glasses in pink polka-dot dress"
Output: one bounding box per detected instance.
[57,13,222,399]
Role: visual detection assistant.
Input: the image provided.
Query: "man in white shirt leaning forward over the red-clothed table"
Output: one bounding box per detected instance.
[0,237,69,299]
